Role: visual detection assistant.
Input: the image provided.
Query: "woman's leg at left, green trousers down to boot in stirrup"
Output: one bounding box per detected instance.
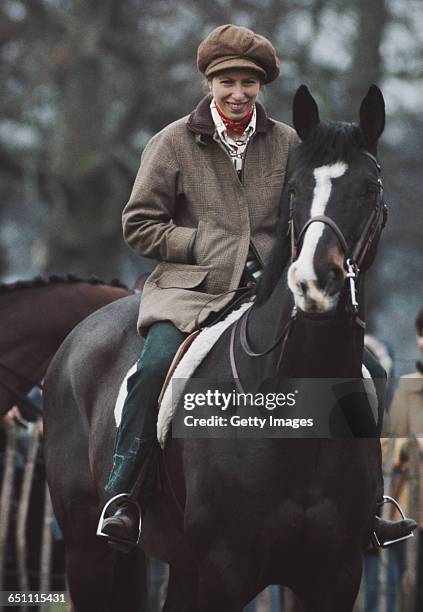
[97,321,187,551]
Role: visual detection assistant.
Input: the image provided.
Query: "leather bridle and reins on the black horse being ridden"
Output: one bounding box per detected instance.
[229,151,388,392]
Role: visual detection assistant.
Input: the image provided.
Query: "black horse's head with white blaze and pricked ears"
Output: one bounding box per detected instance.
[283,85,386,313]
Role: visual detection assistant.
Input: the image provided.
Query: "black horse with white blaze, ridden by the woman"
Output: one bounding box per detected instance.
[45,86,385,612]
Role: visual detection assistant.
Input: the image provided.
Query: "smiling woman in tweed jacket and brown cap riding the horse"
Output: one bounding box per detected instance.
[101,25,418,545]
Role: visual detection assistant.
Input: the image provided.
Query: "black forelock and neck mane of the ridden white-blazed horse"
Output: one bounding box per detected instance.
[256,121,366,304]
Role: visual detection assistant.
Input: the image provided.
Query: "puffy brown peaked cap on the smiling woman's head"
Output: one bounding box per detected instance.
[197,24,280,83]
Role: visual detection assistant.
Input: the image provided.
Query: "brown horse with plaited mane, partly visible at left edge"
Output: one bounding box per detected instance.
[0,275,131,416]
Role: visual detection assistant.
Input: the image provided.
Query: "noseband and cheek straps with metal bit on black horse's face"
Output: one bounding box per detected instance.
[288,151,388,310]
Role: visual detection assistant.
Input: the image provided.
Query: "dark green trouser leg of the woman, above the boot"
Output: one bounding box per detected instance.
[105,321,188,499]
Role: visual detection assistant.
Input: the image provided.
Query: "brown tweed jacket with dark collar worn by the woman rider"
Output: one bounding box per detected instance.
[123,96,298,334]
